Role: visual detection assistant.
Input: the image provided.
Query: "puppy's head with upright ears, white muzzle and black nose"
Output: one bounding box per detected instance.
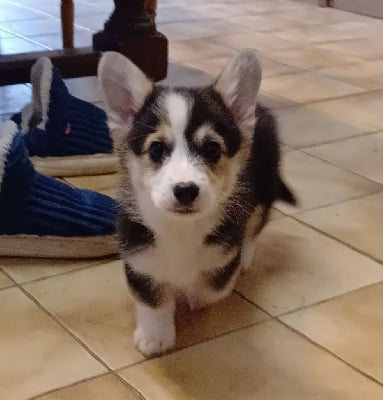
[98,50,261,217]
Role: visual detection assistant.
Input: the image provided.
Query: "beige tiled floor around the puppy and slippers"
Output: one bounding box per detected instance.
[0,0,383,400]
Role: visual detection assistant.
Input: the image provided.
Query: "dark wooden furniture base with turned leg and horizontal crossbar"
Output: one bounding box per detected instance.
[0,0,168,86]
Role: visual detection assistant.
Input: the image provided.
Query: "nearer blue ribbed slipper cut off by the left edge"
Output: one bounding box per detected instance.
[0,121,118,258]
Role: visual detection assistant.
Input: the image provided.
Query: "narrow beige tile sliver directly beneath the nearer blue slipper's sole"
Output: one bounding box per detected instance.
[0,257,100,283]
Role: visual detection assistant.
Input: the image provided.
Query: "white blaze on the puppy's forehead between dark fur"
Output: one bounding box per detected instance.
[164,92,192,136]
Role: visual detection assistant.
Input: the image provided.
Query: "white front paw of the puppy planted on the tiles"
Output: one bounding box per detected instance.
[134,328,176,357]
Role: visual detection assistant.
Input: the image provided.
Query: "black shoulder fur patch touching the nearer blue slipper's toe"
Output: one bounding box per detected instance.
[117,212,155,253]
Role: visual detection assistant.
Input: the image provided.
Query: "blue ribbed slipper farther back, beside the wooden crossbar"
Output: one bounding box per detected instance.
[12,57,118,176]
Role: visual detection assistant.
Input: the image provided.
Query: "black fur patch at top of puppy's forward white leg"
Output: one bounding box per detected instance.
[125,263,163,308]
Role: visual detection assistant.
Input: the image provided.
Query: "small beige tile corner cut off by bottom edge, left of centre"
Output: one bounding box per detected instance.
[36,375,141,400]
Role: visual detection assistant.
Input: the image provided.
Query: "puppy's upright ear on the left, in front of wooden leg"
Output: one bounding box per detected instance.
[97,52,153,132]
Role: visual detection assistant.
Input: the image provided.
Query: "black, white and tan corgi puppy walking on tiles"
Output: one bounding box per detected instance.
[98,50,295,356]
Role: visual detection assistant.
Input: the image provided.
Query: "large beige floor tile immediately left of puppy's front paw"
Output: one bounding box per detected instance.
[25,261,143,368]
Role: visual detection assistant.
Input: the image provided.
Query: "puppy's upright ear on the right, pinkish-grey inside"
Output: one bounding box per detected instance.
[214,49,262,128]
